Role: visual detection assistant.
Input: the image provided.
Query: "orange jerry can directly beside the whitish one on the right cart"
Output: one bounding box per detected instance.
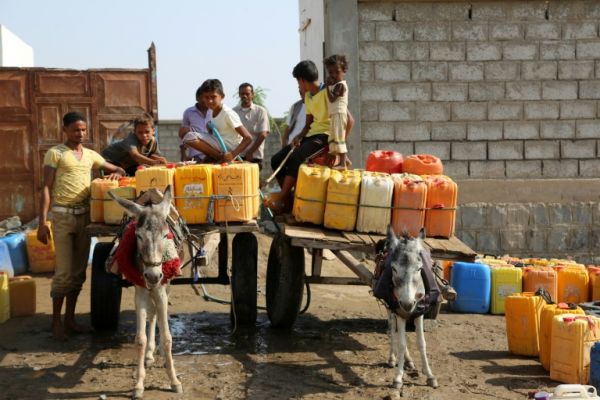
[392,174,427,237]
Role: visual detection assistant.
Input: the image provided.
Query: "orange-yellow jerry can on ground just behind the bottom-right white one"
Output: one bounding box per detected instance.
[550,314,600,385]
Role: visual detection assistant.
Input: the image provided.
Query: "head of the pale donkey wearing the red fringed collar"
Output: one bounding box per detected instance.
[108,186,172,288]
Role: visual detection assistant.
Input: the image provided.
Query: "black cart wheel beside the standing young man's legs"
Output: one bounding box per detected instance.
[90,243,121,331]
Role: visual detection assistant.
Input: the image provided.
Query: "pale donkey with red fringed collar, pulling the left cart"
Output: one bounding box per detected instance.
[109,186,183,399]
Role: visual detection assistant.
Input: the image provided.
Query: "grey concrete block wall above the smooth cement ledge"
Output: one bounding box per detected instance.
[358,0,600,179]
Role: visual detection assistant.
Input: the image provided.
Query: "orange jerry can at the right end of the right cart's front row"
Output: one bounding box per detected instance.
[425,175,458,238]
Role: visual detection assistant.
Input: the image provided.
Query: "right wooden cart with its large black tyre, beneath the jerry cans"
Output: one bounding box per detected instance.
[266,217,476,328]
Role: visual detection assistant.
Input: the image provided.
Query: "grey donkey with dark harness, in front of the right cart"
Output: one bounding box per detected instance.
[374,227,439,390]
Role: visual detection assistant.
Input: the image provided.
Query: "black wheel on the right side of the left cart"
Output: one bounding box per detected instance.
[230,232,258,325]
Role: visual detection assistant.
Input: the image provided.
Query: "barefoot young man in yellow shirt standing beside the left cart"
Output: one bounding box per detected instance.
[37,112,125,340]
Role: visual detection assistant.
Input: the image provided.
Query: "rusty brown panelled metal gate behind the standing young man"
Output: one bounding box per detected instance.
[0,44,158,222]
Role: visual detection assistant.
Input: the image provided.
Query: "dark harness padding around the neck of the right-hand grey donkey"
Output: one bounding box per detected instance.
[373,240,440,319]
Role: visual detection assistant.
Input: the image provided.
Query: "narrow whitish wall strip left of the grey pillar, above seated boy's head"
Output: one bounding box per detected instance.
[298,0,325,80]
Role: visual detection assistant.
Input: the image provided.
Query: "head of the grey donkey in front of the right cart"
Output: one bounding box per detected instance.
[388,227,425,319]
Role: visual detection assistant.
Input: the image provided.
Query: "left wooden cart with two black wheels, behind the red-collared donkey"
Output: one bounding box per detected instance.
[86,221,258,331]
